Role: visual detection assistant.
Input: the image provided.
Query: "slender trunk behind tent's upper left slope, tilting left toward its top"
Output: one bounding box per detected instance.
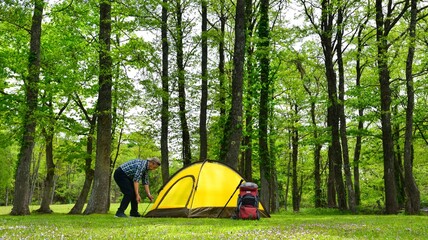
[175,0,192,166]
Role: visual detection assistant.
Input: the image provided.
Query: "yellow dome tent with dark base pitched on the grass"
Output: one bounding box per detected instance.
[145,161,269,218]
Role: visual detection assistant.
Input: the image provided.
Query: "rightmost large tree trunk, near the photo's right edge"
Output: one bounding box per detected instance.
[404,0,421,214]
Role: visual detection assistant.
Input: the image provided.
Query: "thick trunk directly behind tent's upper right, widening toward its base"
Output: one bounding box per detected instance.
[220,0,246,169]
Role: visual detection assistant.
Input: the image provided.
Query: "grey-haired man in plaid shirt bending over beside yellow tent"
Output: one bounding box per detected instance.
[114,157,161,217]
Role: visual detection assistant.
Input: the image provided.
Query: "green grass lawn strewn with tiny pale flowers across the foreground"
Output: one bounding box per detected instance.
[0,204,428,240]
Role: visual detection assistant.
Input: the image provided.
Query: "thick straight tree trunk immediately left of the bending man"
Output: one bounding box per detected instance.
[85,1,112,214]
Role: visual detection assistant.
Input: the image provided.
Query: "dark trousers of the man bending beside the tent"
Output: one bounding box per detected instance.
[114,167,138,215]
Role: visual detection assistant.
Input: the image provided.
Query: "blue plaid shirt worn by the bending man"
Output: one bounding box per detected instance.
[120,158,149,185]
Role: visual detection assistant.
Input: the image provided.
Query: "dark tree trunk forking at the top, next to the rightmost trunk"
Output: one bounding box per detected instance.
[376,0,408,214]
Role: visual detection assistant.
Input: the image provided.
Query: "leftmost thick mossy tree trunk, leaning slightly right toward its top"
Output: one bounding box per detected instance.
[10,0,44,215]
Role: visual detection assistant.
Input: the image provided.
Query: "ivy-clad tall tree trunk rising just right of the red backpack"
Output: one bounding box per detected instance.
[257,0,273,212]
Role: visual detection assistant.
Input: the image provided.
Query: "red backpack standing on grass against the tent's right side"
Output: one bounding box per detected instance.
[236,182,260,220]
